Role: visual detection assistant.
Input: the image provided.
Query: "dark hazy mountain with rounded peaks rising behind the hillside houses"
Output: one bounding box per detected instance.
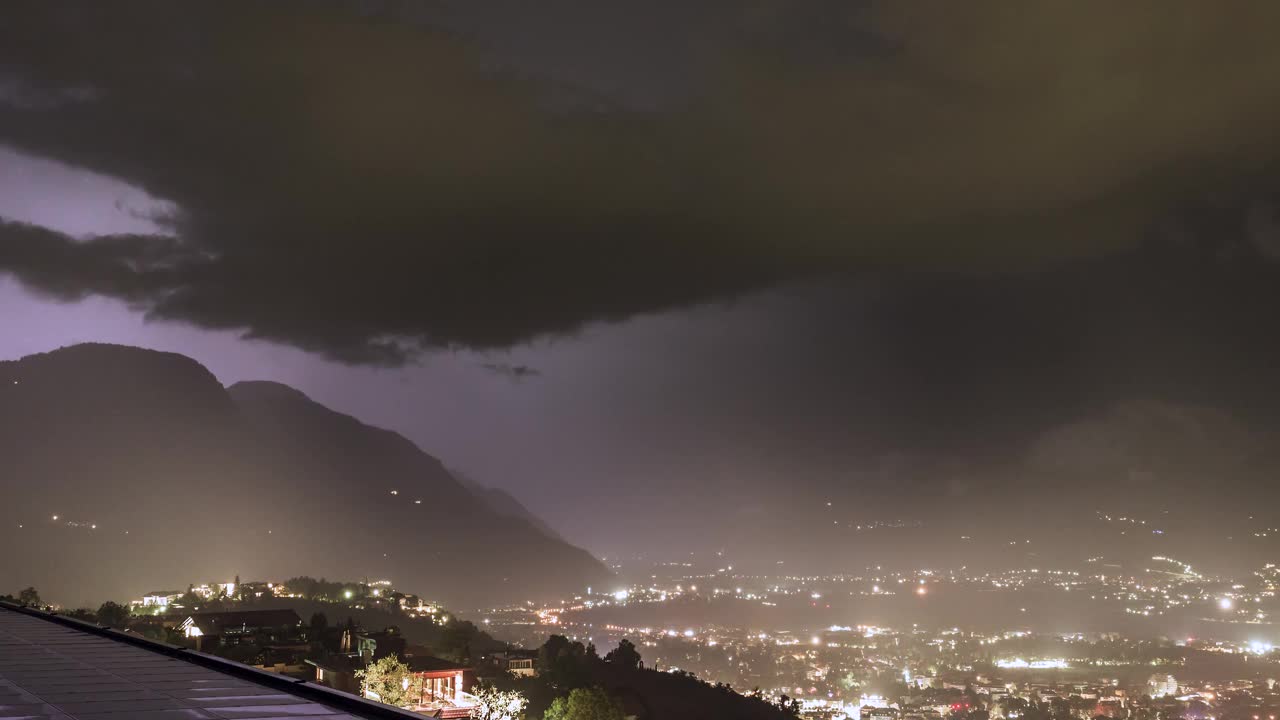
[0,345,612,607]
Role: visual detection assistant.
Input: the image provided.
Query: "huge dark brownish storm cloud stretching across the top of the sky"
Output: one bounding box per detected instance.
[0,1,1280,364]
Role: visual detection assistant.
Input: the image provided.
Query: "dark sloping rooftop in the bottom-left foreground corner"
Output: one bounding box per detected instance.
[0,603,422,720]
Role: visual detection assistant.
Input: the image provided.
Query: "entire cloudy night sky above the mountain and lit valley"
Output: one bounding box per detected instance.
[0,0,1280,555]
